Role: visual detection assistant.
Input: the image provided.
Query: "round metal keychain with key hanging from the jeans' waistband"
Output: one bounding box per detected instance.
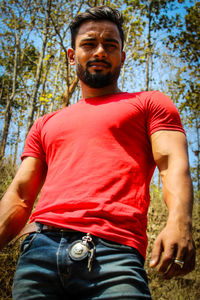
[69,233,96,272]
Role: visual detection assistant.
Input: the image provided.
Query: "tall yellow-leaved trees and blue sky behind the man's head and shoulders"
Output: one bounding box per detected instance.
[0,0,199,182]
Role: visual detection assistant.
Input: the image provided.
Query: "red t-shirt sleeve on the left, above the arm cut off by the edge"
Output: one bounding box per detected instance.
[21,119,45,161]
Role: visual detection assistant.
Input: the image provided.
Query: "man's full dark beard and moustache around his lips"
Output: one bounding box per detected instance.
[76,60,121,89]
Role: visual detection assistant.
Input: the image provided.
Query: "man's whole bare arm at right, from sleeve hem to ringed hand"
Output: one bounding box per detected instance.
[150,131,195,279]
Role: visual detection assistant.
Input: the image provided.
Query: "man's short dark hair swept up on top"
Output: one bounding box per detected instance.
[69,5,124,49]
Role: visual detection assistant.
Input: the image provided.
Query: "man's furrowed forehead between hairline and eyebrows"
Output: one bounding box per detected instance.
[76,20,121,42]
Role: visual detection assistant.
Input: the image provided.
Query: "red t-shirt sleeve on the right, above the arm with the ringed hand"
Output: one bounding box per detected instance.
[146,91,185,136]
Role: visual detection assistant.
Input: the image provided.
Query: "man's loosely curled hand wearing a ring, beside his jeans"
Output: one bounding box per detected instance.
[150,221,195,279]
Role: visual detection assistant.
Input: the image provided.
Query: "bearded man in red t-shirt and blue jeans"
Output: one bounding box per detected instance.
[0,6,195,300]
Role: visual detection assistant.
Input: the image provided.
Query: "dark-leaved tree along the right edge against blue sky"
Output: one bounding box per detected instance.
[167,1,200,195]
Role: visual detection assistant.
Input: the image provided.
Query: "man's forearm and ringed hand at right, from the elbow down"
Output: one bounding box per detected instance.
[150,168,195,279]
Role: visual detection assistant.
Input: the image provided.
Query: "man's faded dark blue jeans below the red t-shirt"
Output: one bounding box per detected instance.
[13,226,151,300]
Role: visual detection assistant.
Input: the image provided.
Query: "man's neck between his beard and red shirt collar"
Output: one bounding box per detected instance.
[80,81,121,98]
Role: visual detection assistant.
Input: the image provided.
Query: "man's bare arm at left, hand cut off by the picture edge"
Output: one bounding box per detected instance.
[0,157,46,249]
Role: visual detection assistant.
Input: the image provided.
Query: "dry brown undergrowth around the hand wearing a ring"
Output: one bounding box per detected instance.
[145,194,200,300]
